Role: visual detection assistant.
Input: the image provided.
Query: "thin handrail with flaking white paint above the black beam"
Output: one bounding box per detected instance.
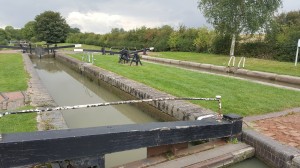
[0,96,221,118]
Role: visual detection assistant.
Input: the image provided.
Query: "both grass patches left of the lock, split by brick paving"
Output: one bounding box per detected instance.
[0,54,37,133]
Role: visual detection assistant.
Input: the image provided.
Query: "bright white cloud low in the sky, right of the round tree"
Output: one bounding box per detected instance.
[66,12,178,34]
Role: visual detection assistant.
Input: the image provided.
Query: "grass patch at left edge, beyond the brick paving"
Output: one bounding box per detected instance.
[0,54,28,92]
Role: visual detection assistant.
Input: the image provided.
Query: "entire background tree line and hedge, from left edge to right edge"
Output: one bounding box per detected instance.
[0,11,300,61]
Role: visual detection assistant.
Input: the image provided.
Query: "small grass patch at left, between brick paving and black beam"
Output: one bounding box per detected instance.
[0,106,37,133]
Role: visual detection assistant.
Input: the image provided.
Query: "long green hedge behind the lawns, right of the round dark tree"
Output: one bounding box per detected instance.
[66,7,300,61]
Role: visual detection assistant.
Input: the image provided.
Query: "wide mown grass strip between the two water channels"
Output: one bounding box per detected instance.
[72,54,300,116]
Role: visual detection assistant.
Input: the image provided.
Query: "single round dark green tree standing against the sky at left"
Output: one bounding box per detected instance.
[35,11,70,43]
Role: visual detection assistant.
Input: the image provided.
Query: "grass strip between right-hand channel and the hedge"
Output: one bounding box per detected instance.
[150,52,300,76]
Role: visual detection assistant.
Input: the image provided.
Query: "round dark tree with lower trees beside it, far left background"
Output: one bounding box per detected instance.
[0,11,80,45]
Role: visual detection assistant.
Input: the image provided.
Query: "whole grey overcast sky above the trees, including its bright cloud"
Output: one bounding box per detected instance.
[0,0,300,34]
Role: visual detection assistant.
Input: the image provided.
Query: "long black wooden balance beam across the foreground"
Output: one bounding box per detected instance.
[0,115,242,167]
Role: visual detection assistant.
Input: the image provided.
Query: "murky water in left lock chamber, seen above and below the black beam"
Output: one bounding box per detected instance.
[32,59,156,167]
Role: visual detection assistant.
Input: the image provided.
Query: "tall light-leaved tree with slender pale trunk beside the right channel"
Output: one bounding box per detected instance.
[198,0,282,56]
